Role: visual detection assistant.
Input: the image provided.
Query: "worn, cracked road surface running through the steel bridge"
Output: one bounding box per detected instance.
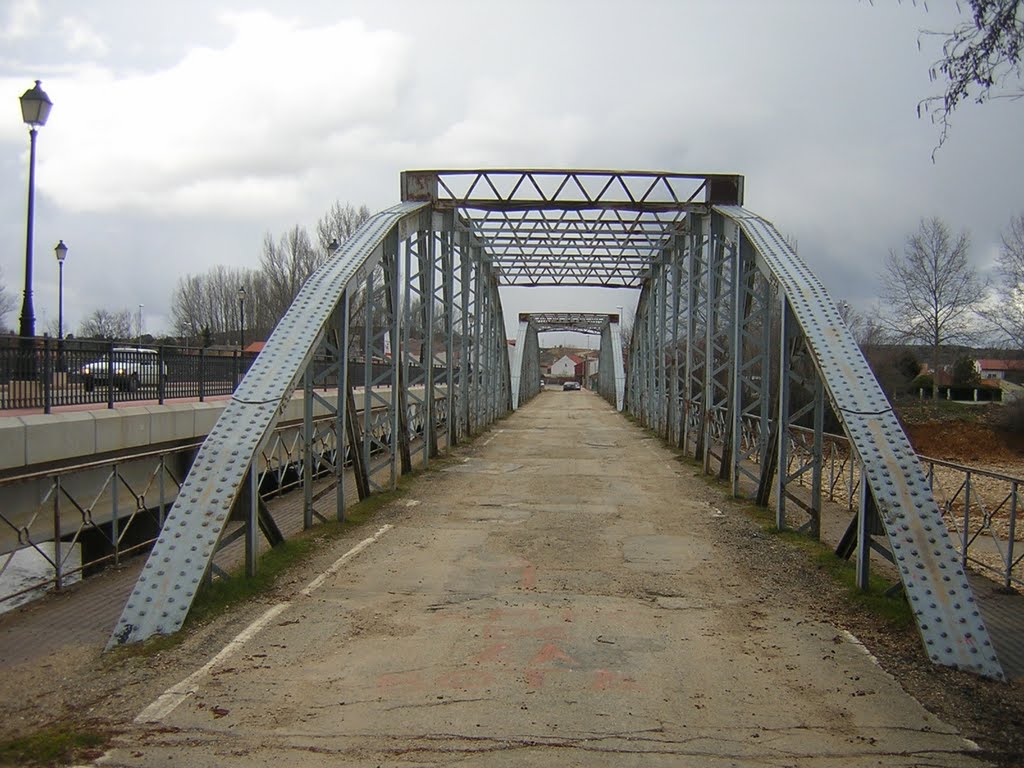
[4,392,1011,766]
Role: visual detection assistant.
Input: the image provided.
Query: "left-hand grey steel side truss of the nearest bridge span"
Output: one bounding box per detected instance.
[109,202,511,647]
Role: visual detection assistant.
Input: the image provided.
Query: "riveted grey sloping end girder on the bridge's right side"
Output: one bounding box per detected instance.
[715,206,1002,678]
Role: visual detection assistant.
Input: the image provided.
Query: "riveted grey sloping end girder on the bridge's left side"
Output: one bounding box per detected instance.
[108,202,429,647]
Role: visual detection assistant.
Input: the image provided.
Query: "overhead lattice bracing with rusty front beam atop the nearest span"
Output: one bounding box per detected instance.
[402,169,742,288]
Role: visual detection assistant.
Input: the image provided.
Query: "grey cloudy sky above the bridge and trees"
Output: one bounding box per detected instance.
[0,0,1024,342]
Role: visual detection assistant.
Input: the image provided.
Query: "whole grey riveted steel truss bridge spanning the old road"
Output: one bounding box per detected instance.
[109,169,1002,678]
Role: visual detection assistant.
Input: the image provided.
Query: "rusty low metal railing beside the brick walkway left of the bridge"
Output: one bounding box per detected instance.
[0,395,447,612]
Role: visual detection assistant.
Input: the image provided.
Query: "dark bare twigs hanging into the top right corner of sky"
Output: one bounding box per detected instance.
[918,0,1024,148]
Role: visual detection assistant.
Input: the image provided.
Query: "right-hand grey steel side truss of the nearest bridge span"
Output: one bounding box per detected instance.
[628,206,1002,678]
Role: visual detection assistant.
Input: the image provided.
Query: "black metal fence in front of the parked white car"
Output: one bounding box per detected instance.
[0,336,255,414]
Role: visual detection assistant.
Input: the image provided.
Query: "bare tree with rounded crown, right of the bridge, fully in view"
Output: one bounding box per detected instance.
[882,218,988,397]
